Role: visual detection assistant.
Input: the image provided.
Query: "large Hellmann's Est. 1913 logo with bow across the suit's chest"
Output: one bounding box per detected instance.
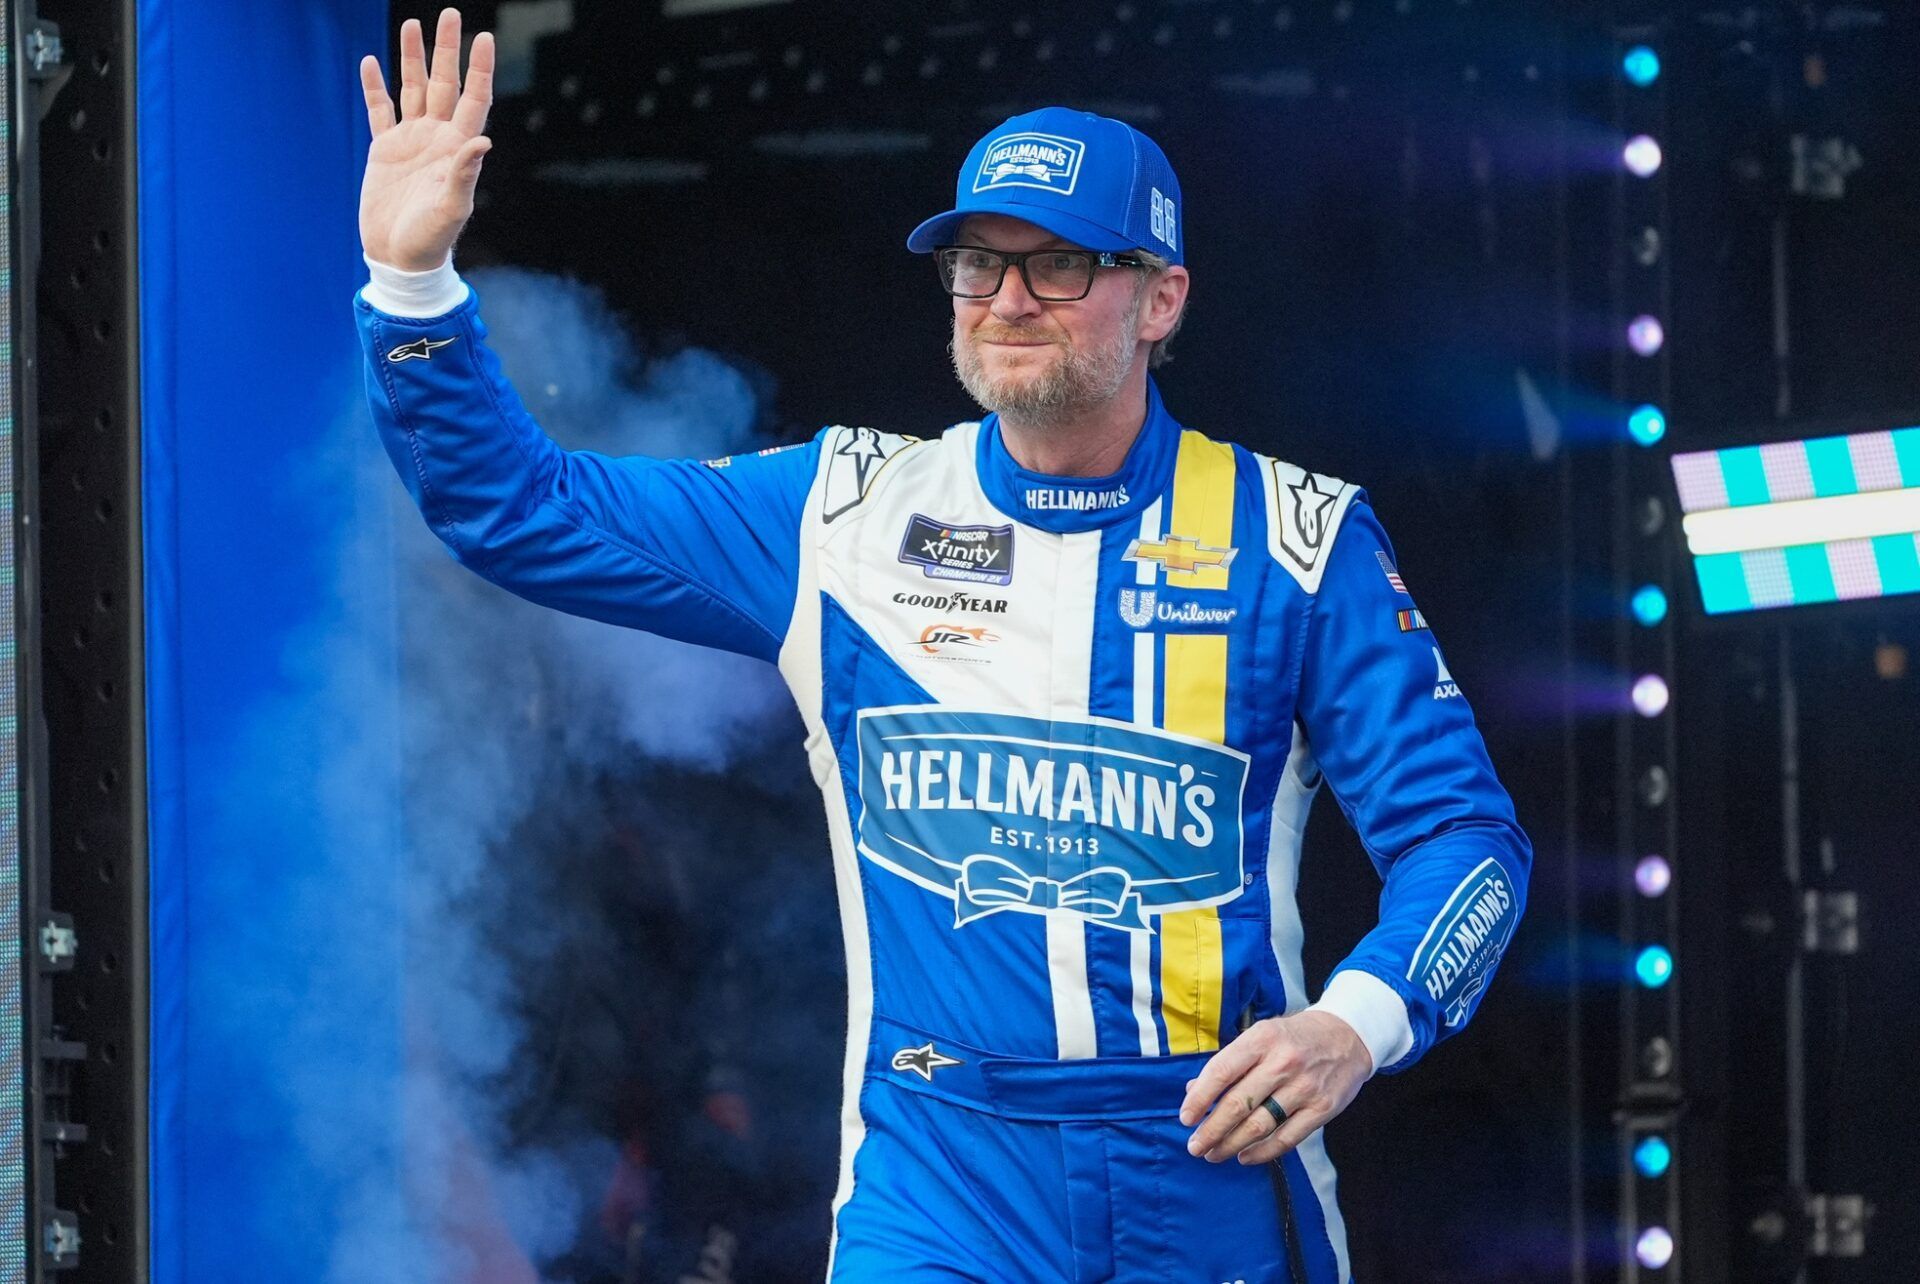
[858,704,1248,933]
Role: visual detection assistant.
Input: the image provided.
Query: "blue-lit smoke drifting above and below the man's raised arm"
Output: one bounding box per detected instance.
[206,269,831,1284]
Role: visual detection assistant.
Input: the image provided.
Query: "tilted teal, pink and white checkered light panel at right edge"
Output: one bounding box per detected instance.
[1672,428,1920,614]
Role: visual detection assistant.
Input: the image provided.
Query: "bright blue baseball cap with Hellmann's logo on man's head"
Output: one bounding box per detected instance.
[906,107,1187,263]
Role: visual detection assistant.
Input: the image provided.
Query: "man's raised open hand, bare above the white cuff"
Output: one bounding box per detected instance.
[361,10,493,273]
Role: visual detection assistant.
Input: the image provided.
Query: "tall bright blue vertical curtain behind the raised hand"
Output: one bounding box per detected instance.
[138,0,403,1284]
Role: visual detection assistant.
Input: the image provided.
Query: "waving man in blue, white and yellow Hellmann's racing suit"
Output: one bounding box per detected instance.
[355,10,1532,1282]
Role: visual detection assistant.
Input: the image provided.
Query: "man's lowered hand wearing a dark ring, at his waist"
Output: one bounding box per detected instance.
[1181,1010,1373,1163]
